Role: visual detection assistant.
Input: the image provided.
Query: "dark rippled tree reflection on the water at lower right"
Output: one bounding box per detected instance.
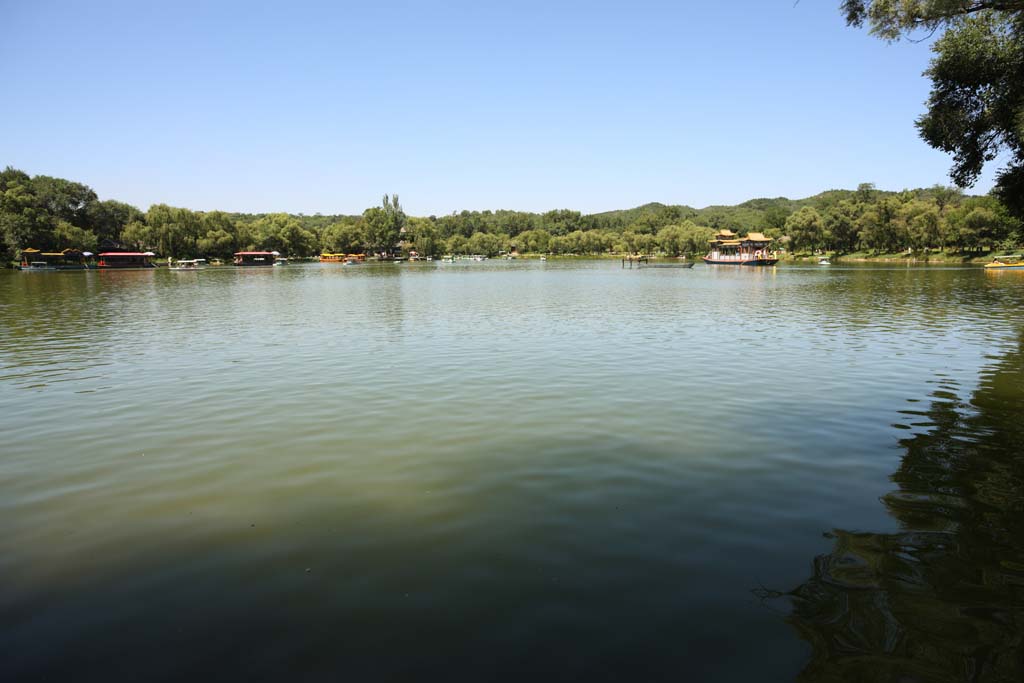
[788,338,1024,681]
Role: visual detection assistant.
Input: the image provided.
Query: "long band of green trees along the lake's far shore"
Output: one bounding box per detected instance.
[0,167,1024,261]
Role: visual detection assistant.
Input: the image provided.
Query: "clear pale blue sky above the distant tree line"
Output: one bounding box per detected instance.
[0,0,991,215]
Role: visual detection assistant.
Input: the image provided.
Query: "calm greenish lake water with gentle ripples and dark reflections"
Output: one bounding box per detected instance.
[0,261,1024,681]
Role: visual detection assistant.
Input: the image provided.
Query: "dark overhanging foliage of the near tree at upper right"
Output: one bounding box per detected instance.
[842,0,1024,217]
